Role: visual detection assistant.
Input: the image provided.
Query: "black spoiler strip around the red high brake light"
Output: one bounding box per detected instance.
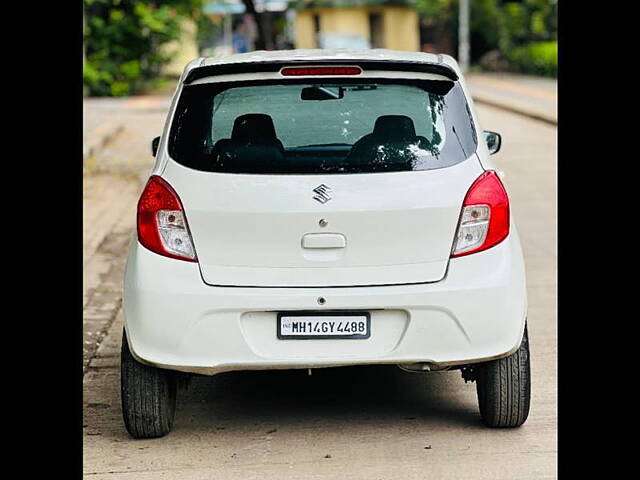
[184,59,458,85]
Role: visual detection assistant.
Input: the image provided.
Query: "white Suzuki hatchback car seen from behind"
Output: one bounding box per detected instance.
[121,50,530,437]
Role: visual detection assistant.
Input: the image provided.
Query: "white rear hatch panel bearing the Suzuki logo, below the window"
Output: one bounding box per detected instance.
[163,155,482,287]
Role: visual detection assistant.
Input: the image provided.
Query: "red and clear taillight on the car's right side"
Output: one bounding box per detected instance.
[451,170,509,257]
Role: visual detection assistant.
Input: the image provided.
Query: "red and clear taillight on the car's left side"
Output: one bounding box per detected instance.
[138,175,197,262]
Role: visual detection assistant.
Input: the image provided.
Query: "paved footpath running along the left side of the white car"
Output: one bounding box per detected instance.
[83,95,169,371]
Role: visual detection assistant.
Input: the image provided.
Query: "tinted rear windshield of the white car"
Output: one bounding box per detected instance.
[169,79,477,174]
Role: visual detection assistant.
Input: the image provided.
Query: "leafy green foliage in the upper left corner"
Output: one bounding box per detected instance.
[84,0,202,96]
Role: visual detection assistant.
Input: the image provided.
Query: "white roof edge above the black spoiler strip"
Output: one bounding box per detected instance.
[183,48,460,79]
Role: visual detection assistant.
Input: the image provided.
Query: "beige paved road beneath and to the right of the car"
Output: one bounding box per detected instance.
[84,100,557,480]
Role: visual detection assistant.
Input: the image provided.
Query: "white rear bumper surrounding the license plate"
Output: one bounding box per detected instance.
[124,228,527,375]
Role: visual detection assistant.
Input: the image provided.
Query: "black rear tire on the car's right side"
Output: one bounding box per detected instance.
[476,325,531,428]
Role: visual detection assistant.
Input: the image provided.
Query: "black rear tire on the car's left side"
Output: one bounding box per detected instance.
[120,331,176,438]
